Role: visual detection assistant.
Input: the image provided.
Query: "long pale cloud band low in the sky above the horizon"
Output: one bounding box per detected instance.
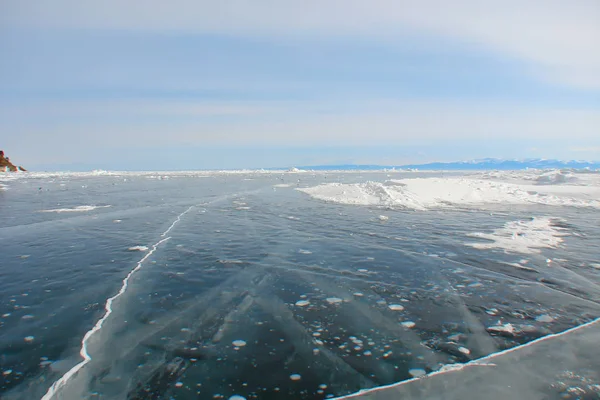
[5,99,600,152]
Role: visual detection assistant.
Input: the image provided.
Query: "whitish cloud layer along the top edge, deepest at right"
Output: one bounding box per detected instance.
[0,0,600,90]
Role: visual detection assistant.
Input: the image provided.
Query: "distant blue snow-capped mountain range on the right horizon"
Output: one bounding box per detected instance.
[296,158,600,171]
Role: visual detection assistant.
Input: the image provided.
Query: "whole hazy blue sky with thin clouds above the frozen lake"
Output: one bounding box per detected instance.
[0,0,600,170]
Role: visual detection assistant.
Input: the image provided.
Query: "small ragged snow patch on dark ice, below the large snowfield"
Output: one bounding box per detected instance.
[465,217,567,255]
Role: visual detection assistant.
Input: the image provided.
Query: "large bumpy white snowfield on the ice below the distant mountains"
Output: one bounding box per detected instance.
[296,172,600,210]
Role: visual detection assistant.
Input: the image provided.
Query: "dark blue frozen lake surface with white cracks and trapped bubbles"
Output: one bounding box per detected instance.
[0,173,600,399]
